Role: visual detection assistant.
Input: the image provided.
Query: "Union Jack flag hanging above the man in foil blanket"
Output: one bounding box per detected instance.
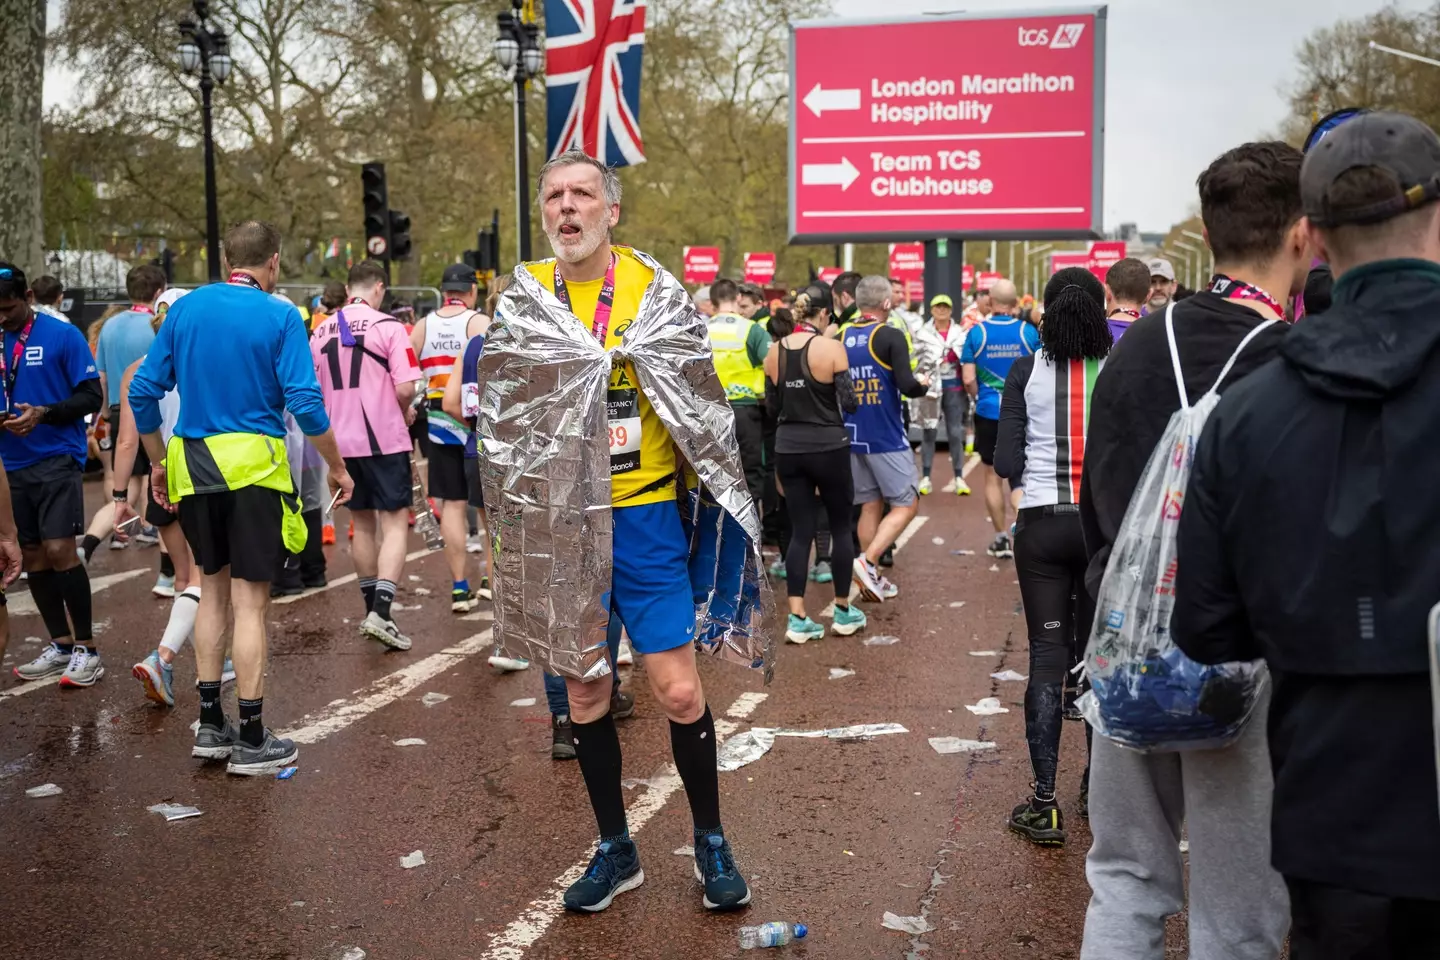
[544,0,645,167]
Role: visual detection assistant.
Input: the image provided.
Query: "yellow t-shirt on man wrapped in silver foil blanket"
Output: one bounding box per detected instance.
[526,246,675,507]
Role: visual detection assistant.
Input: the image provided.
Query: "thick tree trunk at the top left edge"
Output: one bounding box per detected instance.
[0,0,45,272]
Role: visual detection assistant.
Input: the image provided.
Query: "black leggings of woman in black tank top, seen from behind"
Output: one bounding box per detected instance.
[775,446,855,602]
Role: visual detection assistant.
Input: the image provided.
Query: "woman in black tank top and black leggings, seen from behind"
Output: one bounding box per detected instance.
[765,285,865,643]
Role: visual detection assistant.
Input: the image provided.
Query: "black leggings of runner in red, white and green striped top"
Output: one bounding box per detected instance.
[1015,507,1094,799]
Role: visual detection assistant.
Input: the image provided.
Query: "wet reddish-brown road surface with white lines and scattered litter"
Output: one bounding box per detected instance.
[0,466,1179,960]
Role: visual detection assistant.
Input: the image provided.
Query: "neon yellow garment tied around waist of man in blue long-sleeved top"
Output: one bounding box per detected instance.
[166,433,307,553]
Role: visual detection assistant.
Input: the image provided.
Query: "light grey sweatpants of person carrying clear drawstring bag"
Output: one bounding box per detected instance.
[1080,695,1290,960]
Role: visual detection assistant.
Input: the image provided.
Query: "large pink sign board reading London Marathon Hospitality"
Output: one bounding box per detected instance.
[791,7,1106,243]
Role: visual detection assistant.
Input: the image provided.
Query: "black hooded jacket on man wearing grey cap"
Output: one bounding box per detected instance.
[1175,261,1440,910]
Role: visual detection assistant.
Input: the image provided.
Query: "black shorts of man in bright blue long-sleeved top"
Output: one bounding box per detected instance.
[180,486,285,583]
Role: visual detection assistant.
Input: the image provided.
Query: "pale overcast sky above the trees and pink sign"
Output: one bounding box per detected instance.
[45,0,1440,232]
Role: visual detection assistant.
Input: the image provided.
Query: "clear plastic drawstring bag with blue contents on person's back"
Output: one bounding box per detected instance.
[1079,304,1277,751]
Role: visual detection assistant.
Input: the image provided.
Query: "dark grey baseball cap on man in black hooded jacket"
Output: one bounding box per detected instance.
[1300,112,1440,227]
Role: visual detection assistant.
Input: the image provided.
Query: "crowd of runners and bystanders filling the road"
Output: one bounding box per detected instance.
[0,111,1440,960]
